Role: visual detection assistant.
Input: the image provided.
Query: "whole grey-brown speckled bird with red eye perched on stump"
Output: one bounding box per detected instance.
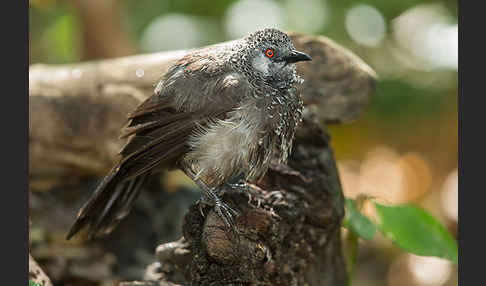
[66,28,311,239]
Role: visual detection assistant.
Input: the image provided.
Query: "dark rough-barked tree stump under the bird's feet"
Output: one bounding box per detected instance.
[139,115,347,286]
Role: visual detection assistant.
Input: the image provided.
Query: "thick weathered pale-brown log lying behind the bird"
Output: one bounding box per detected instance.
[29,34,375,189]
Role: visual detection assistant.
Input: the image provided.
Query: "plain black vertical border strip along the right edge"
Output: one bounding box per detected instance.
[458,1,474,285]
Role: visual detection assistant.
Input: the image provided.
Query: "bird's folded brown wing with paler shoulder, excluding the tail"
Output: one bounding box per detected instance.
[116,55,249,179]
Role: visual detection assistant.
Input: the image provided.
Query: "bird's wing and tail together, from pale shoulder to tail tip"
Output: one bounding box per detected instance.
[68,51,248,239]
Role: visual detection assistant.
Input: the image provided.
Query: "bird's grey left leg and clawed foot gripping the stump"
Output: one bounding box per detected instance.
[183,167,239,229]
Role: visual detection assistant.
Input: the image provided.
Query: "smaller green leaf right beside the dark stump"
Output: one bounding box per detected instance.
[343,199,376,240]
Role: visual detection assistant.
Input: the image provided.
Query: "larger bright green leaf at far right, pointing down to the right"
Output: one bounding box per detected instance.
[375,203,458,263]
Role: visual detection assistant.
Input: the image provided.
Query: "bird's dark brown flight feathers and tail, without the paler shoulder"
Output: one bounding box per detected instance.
[67,97,195,239]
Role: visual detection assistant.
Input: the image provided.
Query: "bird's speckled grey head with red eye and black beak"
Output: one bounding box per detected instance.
[237,29,311,89]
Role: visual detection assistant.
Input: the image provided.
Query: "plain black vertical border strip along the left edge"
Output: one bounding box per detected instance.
[11,1,29,285]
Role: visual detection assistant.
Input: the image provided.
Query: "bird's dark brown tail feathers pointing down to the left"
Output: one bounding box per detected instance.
[66,167,149,240]
